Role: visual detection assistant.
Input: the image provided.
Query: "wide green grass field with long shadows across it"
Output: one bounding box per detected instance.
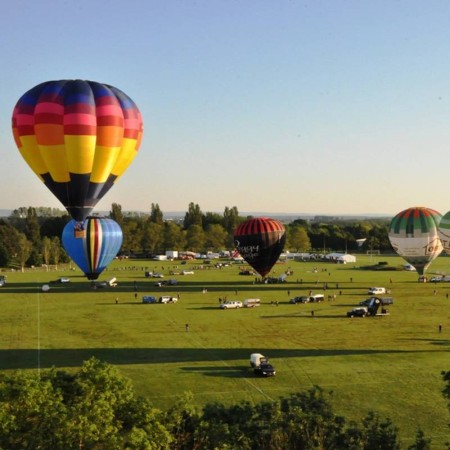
[0,255,450,448]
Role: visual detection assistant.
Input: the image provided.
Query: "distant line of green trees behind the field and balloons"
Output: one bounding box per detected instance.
[0,203,391,268]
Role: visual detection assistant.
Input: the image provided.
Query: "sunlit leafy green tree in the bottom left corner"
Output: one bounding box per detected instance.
[0,358,172,450]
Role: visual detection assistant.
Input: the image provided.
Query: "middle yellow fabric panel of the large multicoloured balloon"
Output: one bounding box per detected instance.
[65,135,96,174]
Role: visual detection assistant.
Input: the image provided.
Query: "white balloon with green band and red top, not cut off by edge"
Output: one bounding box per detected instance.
[389,207,443,276]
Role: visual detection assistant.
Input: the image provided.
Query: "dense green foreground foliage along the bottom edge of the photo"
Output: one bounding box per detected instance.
[0,358,442,450]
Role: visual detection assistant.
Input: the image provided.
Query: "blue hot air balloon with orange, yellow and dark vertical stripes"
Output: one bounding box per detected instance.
[62,217,123,280]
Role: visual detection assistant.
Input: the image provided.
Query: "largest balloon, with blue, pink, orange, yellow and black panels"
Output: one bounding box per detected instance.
[12,80,143,222]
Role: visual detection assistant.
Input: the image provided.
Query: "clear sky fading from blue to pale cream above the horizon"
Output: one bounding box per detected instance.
[0,0,450,215]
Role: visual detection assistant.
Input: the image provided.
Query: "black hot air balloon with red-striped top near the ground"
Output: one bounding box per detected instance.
[234,217,286,277]
